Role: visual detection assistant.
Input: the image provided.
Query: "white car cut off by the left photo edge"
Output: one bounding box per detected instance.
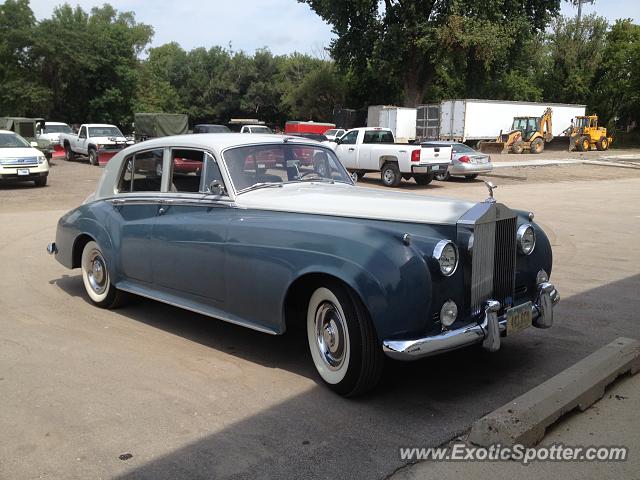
[0,130,49,187]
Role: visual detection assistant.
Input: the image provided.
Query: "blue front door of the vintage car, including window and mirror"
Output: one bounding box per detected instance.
[152,148,234,307]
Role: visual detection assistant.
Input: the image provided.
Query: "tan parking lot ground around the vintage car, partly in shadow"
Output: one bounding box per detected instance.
[0,156,640,479]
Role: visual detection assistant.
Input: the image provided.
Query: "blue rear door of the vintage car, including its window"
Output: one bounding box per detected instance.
[110,148,164,284]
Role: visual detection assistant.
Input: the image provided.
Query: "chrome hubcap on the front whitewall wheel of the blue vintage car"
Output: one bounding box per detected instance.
[315,302,346,370]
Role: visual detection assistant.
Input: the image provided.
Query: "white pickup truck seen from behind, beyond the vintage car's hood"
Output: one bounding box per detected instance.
[330,127,452,187]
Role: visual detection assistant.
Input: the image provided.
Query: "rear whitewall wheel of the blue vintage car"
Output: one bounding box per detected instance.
[81,241,124,308]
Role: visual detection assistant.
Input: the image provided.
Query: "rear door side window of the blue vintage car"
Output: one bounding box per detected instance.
[118,149,164,192]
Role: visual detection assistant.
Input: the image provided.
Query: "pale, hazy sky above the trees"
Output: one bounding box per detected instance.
[31,0,640,57]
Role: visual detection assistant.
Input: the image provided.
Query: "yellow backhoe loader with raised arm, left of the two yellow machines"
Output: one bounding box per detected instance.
[478,108,553,153]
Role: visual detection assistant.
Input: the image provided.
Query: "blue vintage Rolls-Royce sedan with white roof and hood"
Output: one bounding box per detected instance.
[48,134,559,396]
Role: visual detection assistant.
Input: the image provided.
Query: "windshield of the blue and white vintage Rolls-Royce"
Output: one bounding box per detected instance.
[223,144,353,193]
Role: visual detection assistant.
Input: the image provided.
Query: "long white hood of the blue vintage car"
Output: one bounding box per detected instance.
[236,183,475,225]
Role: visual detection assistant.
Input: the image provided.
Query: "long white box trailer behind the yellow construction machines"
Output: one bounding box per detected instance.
[439,99,586,142]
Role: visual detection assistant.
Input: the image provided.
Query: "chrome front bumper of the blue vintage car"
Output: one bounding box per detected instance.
[382,283,560,360]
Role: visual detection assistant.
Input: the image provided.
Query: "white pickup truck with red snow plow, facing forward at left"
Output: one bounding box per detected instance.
[60,123,134,165]
